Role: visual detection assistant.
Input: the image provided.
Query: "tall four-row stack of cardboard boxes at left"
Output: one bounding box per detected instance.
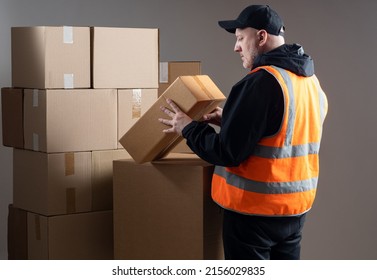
[2,26,158,259]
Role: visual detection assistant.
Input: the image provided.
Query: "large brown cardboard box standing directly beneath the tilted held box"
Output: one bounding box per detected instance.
[113,153,223,260]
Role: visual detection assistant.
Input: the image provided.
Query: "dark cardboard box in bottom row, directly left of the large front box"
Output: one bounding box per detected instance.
[28,211,114,260]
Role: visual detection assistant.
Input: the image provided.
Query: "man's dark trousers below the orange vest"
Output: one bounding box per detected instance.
[223,210,306,260]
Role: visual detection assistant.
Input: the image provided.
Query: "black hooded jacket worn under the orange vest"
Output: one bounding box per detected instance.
[182,44,314,166]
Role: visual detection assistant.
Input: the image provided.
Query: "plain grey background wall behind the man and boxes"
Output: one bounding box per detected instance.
[0,0,377,259]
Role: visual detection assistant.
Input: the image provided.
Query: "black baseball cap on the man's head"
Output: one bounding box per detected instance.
[219,5,285,36]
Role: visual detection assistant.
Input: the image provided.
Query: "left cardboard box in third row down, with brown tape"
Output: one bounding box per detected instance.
[13,149,92,216]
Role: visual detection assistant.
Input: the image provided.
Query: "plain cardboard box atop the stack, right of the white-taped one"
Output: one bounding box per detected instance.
[91,27,159,89]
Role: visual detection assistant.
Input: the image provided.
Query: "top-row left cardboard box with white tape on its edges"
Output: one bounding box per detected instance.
[11,26,90,89]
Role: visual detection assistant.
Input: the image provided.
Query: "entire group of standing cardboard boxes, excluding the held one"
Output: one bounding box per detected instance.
[1,26,221,259]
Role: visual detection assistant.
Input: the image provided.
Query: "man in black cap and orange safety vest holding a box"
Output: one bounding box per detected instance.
[159,5,327,259]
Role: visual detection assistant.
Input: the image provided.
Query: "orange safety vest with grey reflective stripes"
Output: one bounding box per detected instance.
[212,66,328,216]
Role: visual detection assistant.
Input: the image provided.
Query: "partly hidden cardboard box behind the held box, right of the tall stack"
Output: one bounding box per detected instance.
[158,61,202,96]
